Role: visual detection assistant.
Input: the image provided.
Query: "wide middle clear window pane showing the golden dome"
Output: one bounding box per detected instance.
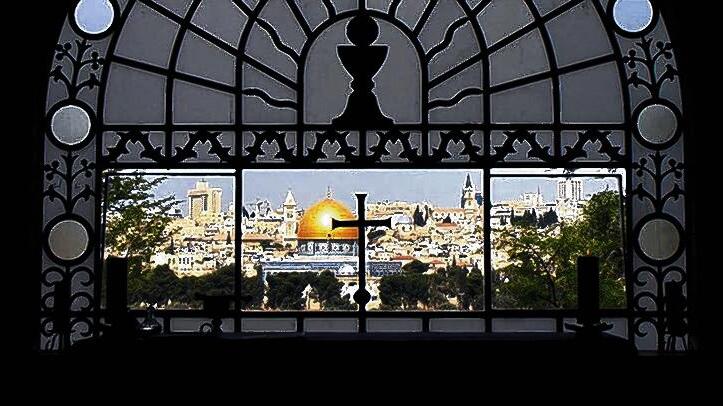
[241,170,484,310]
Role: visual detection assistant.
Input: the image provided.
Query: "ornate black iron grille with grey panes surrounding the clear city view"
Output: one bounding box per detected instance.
[40,0,688,350]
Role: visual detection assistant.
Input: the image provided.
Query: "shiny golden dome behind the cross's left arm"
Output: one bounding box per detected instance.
[298,197,359,240]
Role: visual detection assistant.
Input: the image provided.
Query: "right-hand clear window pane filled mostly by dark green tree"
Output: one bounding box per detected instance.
[490,171,625,309]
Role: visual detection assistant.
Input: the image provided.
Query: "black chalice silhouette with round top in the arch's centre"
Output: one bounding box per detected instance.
[332,15,394,128]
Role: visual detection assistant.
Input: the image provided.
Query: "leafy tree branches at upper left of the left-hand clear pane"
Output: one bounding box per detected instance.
[104,172,180,266]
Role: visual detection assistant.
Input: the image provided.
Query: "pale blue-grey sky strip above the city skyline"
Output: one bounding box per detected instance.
[137,169,618,214]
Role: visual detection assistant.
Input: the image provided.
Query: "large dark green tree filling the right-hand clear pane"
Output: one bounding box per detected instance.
[494,191,625,308]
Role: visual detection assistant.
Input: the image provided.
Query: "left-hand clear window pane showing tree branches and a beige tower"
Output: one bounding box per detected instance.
[104,171,235,309]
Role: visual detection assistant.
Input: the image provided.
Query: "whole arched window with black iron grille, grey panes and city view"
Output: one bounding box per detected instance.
[41,0,687,350]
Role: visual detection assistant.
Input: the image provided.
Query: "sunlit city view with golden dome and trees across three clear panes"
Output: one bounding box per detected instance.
[106,170,625,311]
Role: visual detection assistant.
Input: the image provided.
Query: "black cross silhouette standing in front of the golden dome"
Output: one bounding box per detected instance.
[331,193,392,333]
